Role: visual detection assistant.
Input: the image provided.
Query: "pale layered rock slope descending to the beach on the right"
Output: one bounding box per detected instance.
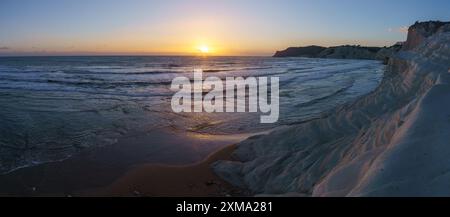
[212,22,450,196]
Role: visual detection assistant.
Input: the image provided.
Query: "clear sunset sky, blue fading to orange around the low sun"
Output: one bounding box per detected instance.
[0,0,450,55]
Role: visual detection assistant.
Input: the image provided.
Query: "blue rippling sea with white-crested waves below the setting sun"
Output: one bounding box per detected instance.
[0,56,385,173]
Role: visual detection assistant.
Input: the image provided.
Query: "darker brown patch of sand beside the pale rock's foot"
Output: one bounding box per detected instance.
[87,145,245,197]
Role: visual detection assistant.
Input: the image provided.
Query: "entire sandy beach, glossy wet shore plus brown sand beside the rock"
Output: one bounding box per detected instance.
[0,129,246,196]
